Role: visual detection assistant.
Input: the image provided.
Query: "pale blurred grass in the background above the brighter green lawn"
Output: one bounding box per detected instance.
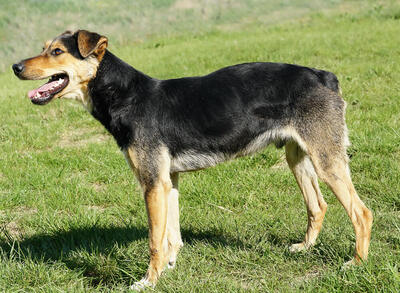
[0,0,356,71]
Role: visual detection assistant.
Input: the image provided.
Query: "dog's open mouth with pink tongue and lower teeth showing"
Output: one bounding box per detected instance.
[28,73,69,105]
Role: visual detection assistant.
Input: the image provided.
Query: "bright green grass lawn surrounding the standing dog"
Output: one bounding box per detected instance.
[0,1,400,292]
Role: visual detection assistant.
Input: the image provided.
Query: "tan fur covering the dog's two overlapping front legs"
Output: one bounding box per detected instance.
[124,147,177,284]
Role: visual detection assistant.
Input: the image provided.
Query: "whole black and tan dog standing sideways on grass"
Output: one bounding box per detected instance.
[13,30,372,288]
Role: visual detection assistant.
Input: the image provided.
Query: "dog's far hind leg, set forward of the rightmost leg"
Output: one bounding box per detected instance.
[285,141,327,252]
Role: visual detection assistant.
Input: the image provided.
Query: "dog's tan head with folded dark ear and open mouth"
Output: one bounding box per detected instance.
[12,30,108,106]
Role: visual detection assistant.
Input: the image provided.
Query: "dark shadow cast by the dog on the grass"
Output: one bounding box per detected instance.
[0,222,346,287]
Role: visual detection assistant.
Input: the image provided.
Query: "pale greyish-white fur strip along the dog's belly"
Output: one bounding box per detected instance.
[171,129,290,173]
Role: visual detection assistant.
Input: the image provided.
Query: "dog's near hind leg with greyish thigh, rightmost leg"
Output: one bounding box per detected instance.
[294,88,372,262]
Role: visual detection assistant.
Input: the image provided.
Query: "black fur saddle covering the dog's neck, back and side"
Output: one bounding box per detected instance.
[89,51,339,160]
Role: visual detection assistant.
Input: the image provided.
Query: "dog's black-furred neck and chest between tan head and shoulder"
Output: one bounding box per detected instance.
[88,51,158,148]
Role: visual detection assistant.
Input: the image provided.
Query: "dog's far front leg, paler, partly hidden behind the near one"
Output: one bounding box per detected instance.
[167,173,183,268]
